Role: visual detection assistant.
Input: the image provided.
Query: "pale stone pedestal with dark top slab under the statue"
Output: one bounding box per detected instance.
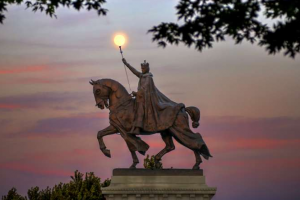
[102,169,217,200]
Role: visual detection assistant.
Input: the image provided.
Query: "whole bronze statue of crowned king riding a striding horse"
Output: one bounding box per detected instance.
[90,59,212,169]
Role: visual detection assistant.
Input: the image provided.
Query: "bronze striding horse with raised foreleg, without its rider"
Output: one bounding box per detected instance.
[90,79,212,169]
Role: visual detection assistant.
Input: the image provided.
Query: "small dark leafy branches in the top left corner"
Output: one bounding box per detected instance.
[0,0,107,23]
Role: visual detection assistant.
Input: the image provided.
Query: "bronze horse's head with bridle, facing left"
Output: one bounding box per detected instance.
[90,80,111,110]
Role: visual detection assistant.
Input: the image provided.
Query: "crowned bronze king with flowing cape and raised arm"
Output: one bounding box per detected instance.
[122,58,184,135]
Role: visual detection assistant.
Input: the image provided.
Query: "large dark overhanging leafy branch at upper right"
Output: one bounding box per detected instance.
[149,0,300,58]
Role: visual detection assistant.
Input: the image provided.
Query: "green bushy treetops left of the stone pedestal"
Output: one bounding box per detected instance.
[2,171,110,200]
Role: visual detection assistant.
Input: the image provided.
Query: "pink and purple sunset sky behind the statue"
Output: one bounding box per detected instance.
[0,0,300,200]
